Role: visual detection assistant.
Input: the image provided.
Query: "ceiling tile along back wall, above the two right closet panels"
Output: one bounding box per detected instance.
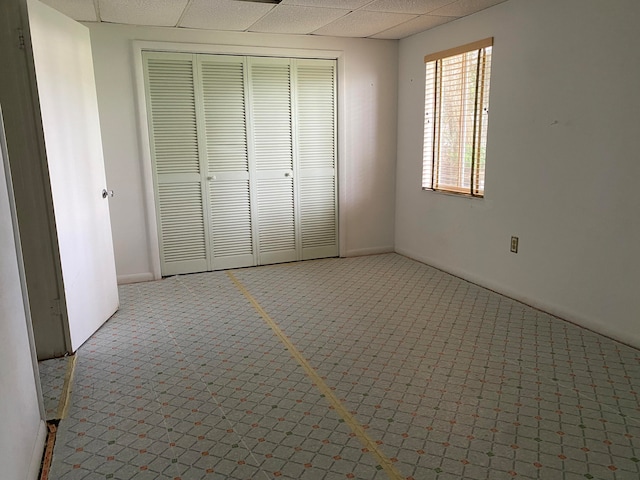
[249,5,349,34]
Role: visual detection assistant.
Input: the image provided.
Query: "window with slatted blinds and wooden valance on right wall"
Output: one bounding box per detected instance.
[422,38,493,197]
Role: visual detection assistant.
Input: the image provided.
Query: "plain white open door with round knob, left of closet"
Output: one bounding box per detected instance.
[28,0,118,351]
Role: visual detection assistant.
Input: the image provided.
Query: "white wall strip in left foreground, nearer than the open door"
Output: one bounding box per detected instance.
[0,107,45,479]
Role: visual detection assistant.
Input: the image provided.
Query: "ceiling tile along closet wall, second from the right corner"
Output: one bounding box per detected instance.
[313,10,415,37]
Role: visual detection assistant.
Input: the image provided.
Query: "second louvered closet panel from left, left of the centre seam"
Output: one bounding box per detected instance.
[198,55,257,270]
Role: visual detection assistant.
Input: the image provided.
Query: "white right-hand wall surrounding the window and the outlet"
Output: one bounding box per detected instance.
[396,0,640,346]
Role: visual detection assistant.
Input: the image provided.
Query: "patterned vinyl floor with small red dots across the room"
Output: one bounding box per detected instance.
[50,254,640,480]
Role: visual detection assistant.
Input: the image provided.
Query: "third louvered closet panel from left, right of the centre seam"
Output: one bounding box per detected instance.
[248,58,299,265]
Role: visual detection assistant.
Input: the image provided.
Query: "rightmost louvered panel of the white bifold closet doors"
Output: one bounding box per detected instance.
[293,60,338,260]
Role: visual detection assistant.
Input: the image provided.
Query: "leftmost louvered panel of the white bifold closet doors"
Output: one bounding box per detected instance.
[143,52,209,275]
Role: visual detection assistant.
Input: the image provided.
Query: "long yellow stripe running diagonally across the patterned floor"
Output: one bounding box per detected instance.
[227,271,404,480]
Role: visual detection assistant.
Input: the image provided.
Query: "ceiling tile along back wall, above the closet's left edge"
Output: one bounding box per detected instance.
[98,0,187,26]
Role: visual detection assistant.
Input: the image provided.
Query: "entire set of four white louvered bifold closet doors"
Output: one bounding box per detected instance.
[143,52,338,275]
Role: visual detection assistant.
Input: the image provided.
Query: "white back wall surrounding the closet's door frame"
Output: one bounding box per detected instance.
[86,23,398,282]
